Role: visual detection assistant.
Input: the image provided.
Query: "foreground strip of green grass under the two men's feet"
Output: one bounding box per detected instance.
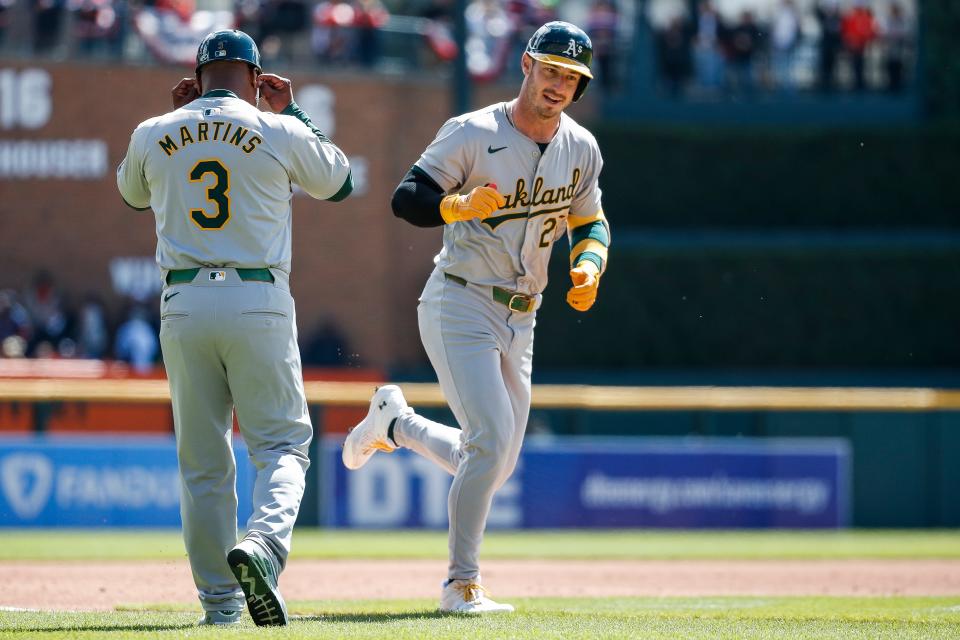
[0,597,960,640]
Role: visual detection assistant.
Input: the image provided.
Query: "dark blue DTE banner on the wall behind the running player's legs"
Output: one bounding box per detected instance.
[318,438,850,528]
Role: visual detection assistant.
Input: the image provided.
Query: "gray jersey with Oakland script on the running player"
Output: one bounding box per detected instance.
[416,103,603,294]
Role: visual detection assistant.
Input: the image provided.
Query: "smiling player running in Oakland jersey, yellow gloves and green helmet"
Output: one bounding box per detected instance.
[343,22,610,613]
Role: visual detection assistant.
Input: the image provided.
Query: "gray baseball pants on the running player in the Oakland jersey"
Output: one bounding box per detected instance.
[394,269,535,579]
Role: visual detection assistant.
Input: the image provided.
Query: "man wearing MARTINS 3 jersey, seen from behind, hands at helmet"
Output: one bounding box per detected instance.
[117,31,353,625]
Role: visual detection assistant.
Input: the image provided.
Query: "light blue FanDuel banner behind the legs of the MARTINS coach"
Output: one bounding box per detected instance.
[0,436,254,527]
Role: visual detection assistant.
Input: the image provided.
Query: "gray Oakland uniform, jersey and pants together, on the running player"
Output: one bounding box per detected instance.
[384,103,609,580]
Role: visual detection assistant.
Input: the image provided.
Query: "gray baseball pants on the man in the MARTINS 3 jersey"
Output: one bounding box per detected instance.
[160,269,313,610]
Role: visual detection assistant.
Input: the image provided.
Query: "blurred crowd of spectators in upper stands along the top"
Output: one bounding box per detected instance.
[0,0,916,97]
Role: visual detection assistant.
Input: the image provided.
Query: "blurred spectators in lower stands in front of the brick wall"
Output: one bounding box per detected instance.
[0,271,352,373]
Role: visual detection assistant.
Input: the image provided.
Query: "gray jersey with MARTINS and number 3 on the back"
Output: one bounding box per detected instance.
[117,91,350,273]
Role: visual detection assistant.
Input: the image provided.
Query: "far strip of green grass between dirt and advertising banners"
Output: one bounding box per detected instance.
[0,529,960,561]
